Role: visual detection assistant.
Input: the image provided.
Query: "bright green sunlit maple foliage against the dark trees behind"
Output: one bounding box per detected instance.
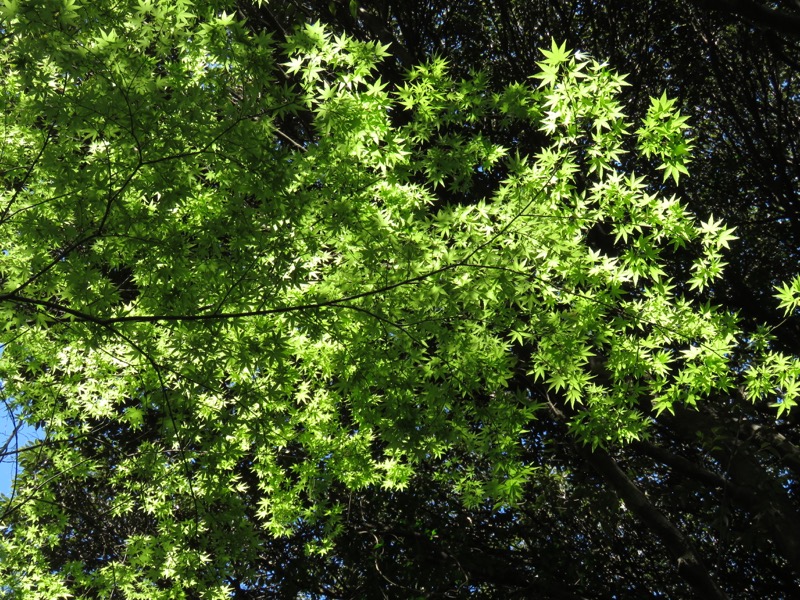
[0,0,798,599]
